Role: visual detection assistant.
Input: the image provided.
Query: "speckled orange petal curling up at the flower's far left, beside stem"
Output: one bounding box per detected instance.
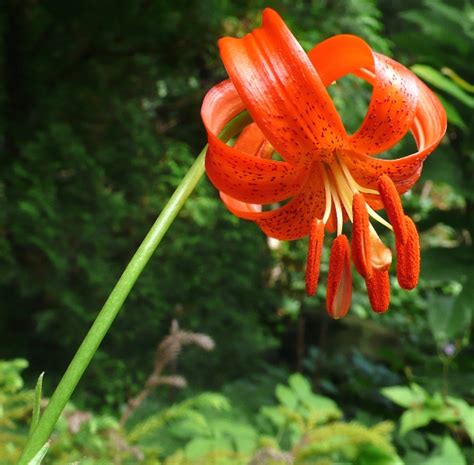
[201,81,307,204]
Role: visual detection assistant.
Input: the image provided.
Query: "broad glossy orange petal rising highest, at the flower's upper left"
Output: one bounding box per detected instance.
[219,8,346,164]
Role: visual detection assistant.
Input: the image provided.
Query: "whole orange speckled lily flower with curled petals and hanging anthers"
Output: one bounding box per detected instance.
[201,9,446,318]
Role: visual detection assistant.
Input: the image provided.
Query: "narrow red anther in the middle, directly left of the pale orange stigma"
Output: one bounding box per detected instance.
[351,193,372,278]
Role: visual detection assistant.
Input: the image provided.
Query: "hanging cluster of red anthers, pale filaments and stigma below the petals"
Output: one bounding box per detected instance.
[306,155,420,319]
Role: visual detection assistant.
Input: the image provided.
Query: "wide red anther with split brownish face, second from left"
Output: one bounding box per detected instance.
[326,234,352,319]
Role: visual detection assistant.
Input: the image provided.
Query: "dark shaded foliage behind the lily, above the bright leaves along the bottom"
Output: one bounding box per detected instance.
[0,0,474,462]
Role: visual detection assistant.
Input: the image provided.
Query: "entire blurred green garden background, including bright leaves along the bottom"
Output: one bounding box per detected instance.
[0,0,474,465]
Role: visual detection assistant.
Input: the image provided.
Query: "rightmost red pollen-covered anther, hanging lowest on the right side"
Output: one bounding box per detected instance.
[395,216,420,290]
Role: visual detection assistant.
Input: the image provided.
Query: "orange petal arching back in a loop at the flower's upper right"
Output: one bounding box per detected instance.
[309,35,418,155]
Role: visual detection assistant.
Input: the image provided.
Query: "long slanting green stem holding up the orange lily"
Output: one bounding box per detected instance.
[18,112,250,465]
